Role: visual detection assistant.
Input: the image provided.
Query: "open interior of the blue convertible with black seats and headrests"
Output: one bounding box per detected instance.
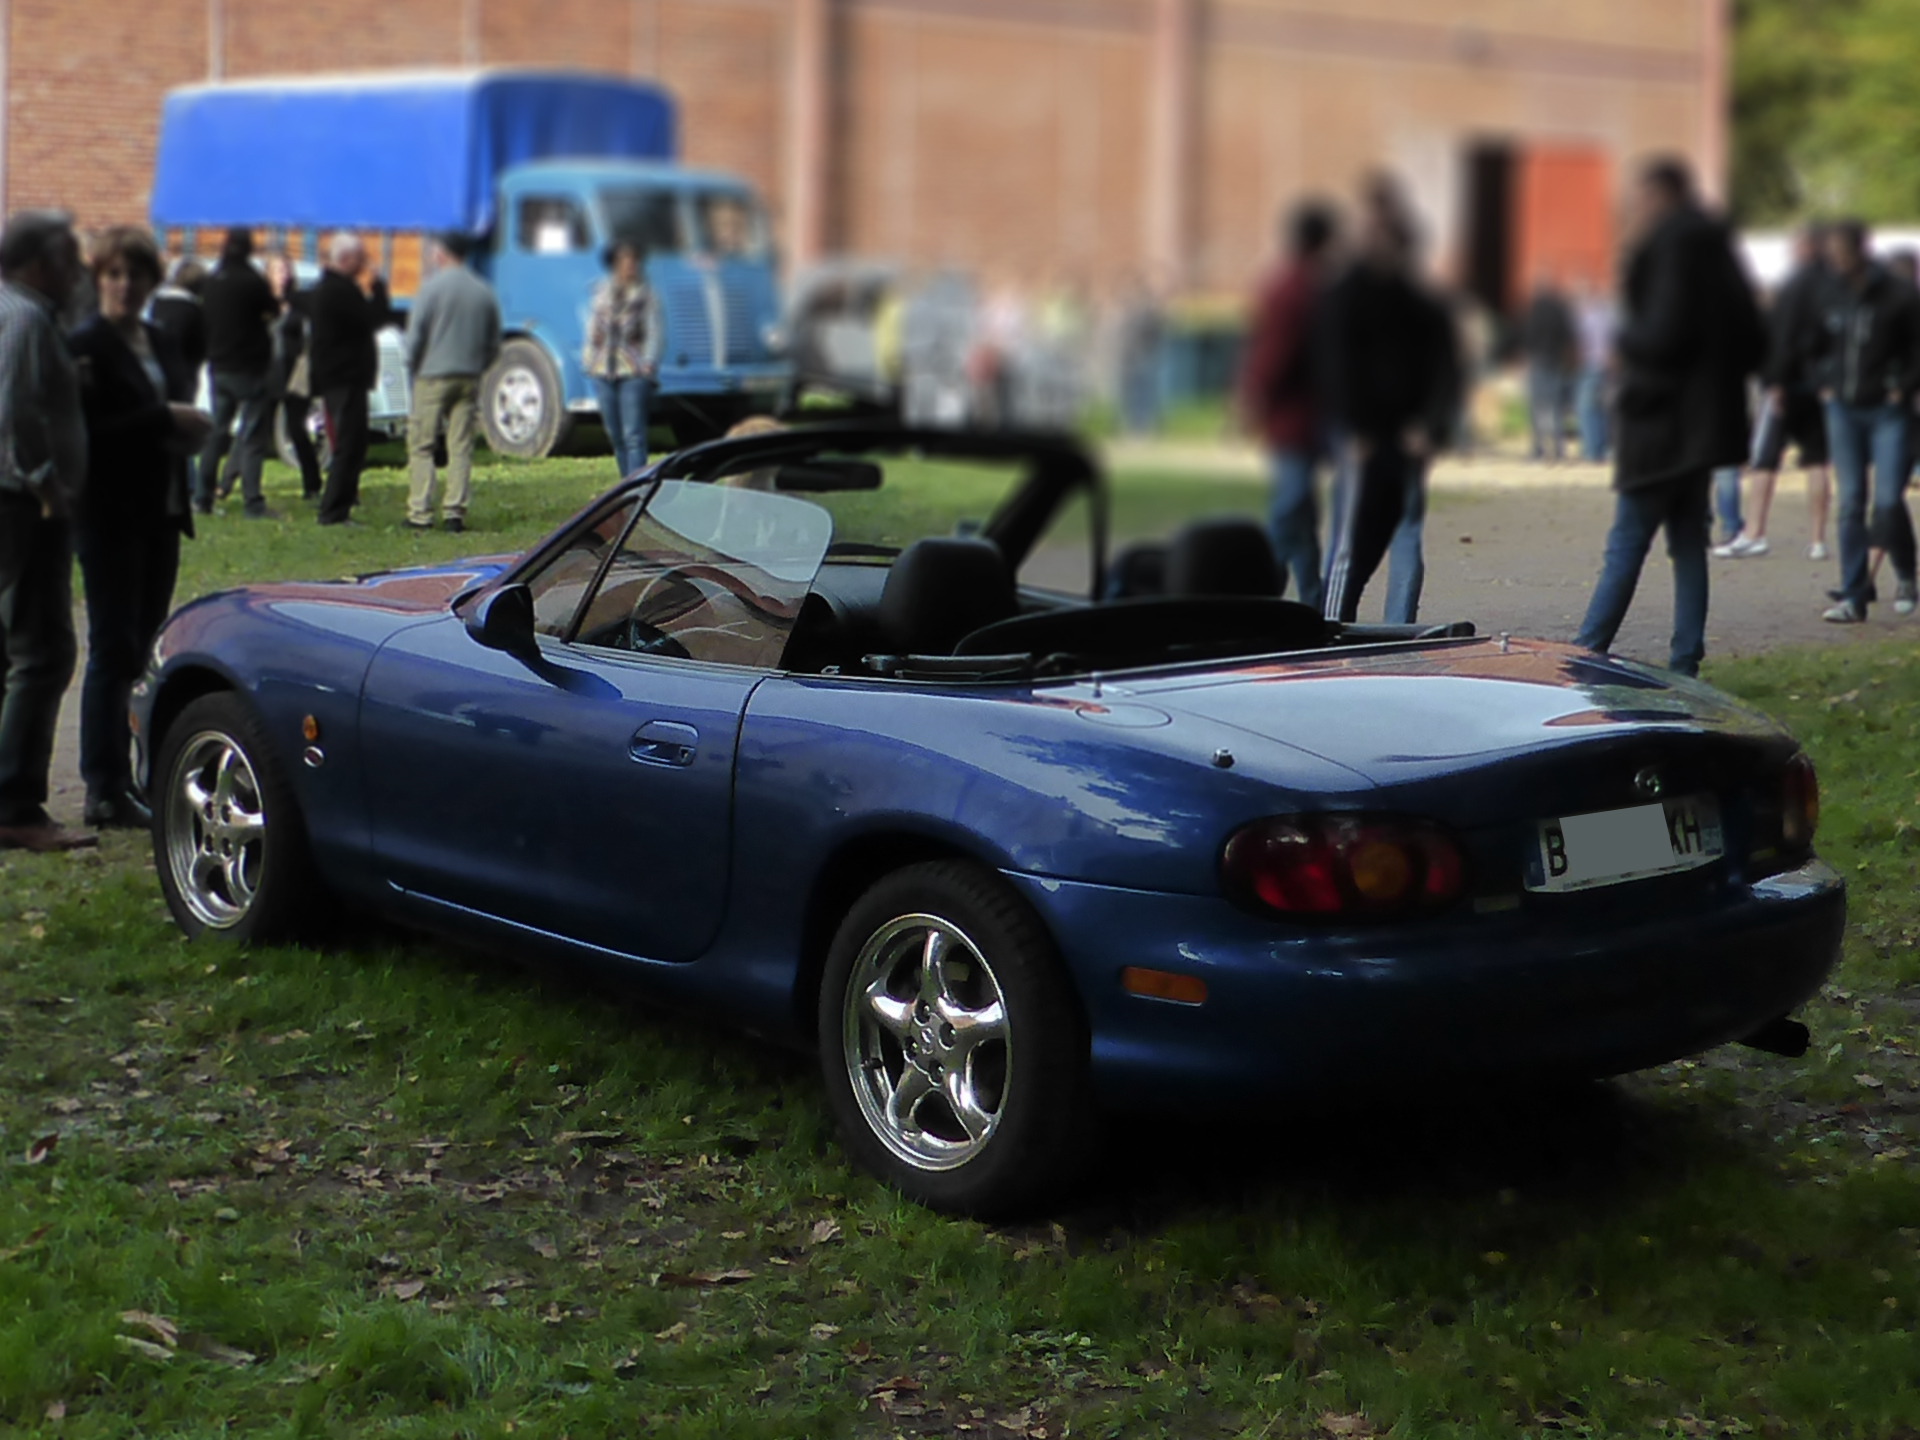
[506,430,1473,680]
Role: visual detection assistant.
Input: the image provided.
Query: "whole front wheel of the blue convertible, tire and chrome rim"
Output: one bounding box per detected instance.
[152,693,324,945]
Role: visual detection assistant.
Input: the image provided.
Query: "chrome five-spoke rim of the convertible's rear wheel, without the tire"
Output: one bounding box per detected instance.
[841,914,1014,1171]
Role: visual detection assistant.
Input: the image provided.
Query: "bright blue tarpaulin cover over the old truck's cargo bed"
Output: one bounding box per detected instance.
[152,69,676,234]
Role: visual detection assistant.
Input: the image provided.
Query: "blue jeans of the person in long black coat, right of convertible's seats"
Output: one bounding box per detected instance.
[1574,472,1709,676]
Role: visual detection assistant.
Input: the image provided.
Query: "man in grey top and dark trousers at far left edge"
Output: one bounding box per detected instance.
[0,209,96,851]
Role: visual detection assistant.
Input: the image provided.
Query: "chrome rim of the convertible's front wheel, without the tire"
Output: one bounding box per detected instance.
[165,730,267,929]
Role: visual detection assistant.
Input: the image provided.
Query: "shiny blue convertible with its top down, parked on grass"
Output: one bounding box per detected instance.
[134,426,1845,1213]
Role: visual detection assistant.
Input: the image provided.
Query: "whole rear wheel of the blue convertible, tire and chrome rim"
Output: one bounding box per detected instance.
[818,860,1092,1217]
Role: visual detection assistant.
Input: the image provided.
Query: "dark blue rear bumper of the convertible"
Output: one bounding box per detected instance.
[1008,860,1847,1108]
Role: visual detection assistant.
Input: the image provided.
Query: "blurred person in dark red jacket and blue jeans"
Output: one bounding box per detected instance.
[1238,200,1338,611]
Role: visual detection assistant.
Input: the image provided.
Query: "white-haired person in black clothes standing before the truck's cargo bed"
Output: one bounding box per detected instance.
[307,232,397,524]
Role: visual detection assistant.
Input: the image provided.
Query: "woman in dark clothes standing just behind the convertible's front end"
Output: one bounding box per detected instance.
[69,227,211,828]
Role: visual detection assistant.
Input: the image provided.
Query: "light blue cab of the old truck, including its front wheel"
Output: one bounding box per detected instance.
[480,159,791,455]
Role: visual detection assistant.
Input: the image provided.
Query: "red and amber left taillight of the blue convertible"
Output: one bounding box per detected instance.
[1219,816,1467,920]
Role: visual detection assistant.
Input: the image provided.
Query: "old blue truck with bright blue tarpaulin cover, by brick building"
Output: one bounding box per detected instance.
[152,69,793,457]
